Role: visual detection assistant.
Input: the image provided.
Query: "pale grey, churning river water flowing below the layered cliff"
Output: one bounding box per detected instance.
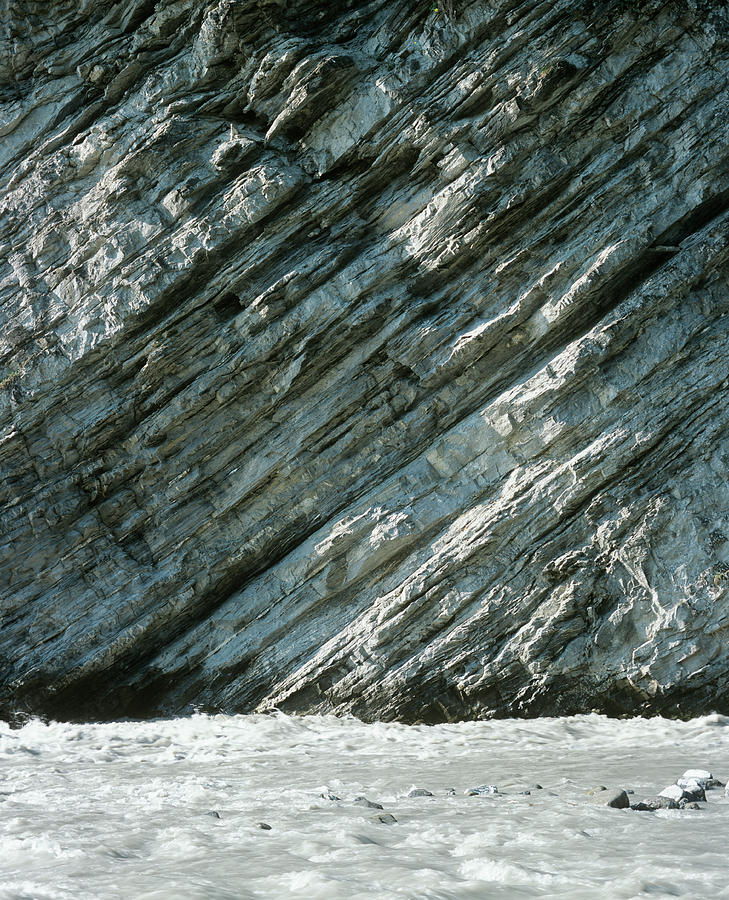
[0,714,729,900]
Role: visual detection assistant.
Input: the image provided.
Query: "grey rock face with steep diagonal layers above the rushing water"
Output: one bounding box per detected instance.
[0,0,729,722]
